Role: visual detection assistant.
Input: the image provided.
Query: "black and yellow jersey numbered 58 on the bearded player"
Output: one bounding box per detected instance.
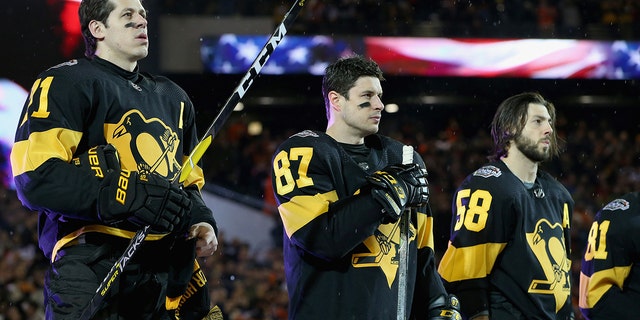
[438,161,573,319]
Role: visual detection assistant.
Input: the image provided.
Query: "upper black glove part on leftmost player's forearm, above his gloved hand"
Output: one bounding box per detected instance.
[73,144,120,179]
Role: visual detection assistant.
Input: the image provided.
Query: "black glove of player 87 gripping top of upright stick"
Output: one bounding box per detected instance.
[367,164,429,222]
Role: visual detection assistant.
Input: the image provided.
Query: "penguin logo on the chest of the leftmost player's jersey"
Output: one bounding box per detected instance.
[105,110,180,180]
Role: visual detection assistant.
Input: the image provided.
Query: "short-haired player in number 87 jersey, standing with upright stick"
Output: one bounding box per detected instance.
[272,56,459,320]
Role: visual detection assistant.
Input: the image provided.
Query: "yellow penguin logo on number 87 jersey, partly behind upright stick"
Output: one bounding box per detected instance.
[351,221,416,288]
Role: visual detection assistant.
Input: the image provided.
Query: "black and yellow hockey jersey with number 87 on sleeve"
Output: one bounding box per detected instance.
[272,131,444,320]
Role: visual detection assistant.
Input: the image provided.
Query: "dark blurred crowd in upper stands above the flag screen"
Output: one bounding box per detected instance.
[159,0,640,39]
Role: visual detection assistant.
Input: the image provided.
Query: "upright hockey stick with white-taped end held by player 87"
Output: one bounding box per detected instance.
[397,146,413,320]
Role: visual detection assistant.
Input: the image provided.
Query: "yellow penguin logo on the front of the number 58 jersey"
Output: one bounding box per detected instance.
[527,219,571,312]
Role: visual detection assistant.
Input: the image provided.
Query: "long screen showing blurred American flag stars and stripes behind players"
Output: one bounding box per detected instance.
[201,34,640,79]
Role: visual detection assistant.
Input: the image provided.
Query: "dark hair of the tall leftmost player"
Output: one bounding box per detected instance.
[78,0,116,58]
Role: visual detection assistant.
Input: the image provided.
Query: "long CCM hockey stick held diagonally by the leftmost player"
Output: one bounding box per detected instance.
[80,0,305,320]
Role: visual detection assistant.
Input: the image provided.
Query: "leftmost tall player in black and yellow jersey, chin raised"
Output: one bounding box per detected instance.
[11,0,218,319]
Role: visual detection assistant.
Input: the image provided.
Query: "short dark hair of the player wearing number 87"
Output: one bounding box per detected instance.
[322,55,384,119]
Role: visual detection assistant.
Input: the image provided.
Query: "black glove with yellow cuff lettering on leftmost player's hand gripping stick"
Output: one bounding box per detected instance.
[98,170,191,233]
